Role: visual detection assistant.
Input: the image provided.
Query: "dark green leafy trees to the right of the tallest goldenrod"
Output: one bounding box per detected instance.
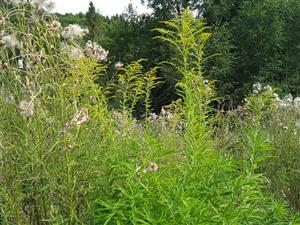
[202,0,299,103]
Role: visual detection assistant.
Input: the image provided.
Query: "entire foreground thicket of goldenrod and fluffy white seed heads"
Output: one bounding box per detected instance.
[0,1,300,225]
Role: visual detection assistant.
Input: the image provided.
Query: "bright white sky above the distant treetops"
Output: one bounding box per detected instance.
[52,0,151,16]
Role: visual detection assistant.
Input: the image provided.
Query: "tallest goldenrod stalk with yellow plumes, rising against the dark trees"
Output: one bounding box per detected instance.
[156,10,214,149]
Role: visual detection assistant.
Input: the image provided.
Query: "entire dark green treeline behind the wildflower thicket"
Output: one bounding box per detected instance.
[58,0,300,111]
